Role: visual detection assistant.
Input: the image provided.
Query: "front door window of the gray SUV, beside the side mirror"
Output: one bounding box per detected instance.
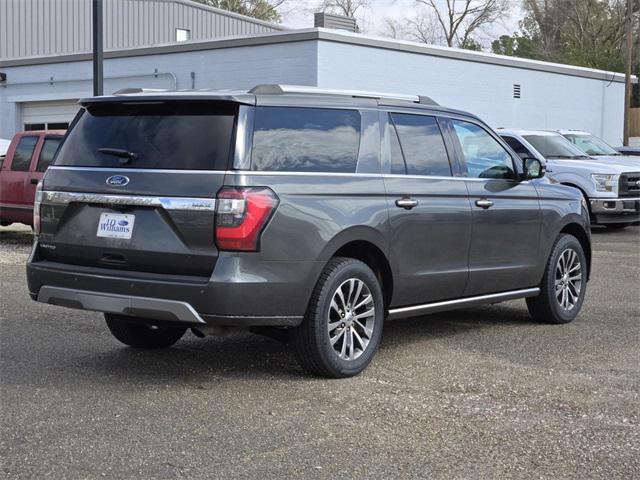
[451,120,515,179]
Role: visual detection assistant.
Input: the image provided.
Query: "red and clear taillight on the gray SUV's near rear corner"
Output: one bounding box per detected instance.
[216,187,278,252]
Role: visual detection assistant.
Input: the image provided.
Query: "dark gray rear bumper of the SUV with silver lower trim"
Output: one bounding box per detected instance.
[27,247,322,326]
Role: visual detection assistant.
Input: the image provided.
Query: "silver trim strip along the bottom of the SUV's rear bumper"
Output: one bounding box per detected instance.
[37,285,206,324]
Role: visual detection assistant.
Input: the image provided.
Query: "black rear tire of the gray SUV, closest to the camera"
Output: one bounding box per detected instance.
[290,257,385,378]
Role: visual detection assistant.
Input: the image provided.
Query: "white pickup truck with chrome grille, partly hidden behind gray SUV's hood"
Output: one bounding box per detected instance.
[497,129,640,228]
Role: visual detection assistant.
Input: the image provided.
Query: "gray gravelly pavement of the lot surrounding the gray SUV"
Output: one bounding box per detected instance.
[0,227,640,479]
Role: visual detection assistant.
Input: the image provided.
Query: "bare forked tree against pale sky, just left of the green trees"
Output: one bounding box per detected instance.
[416,0,508,48]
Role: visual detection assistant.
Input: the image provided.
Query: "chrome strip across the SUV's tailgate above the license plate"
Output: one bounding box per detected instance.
[42,191,216,212]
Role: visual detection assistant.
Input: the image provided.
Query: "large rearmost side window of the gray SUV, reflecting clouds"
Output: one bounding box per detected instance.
[252,107,361,173]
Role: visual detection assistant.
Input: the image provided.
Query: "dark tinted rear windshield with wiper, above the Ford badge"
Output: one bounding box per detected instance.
[54,101,237,170]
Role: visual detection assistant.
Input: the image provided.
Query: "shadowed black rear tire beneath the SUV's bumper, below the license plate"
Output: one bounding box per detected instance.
[104,313,187,349]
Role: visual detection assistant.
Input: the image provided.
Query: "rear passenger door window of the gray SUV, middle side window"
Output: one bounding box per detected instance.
[391,113,451,177]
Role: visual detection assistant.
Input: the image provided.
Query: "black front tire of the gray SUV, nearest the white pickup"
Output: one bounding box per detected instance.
[527,234,588,324]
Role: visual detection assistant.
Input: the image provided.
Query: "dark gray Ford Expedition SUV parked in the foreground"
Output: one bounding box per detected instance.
[27,85,591,377]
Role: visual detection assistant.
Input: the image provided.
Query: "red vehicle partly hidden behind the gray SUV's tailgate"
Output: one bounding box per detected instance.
[0,130,65,226]
